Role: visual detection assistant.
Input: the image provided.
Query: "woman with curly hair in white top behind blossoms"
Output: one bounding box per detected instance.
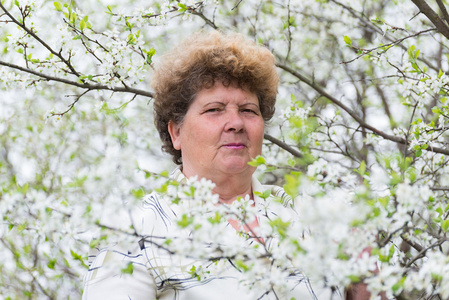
[83,32,352,300]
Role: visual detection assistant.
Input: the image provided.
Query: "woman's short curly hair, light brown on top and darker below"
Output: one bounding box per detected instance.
[152,31,279,164]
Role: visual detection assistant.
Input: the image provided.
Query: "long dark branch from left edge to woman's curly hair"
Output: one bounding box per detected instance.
[0,60,153,98]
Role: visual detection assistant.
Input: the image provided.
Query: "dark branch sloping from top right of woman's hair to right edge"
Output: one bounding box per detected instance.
[276,63,449,155]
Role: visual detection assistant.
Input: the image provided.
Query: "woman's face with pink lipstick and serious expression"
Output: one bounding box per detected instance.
[168,82,264,179]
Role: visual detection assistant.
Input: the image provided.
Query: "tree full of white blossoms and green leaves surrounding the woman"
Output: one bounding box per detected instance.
[0,0,449,299]
